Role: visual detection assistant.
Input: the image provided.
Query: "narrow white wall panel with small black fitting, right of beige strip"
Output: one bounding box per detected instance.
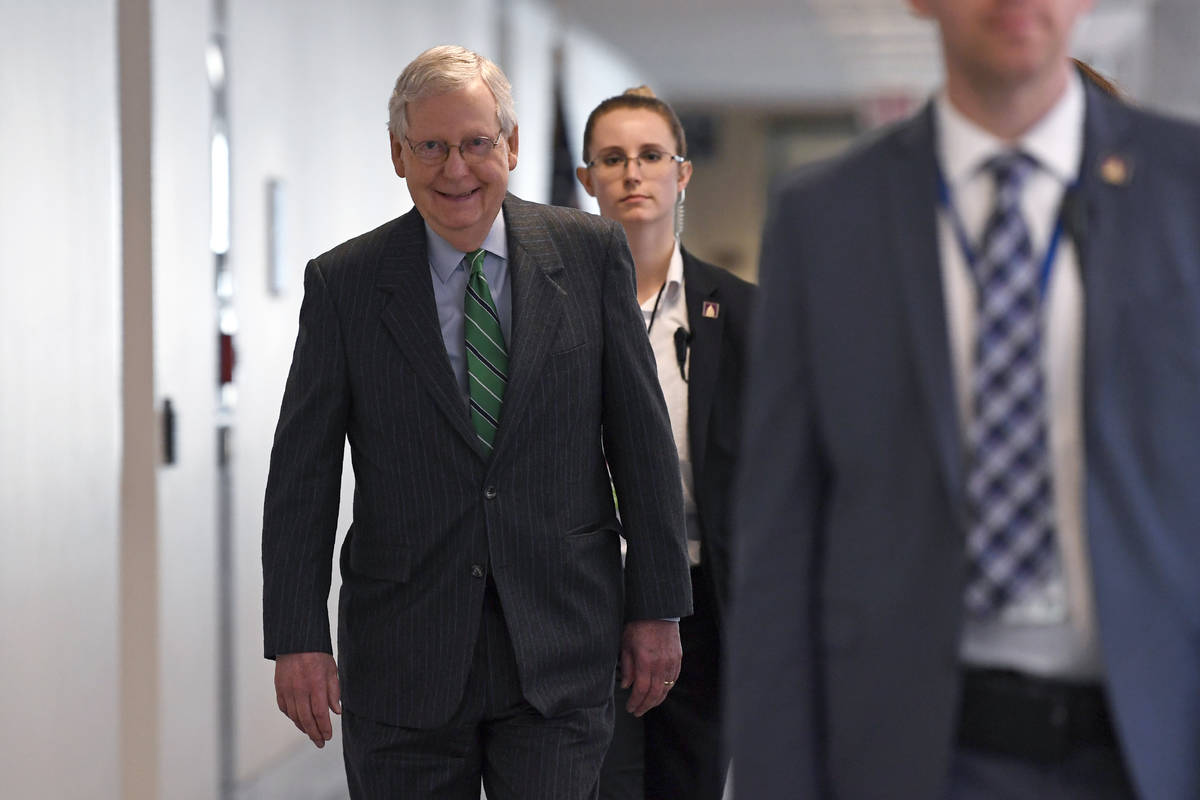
[151,0,220,800]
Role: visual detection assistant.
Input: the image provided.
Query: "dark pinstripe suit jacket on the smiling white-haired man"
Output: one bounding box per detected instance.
[263,196,690,727]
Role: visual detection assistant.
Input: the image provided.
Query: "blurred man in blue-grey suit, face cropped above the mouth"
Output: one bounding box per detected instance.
[731,0,1200,800]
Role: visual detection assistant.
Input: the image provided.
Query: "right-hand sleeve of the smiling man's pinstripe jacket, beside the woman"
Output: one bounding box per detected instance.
[592,224,691,620]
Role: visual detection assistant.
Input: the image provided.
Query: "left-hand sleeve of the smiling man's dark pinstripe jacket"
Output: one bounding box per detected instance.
[263,260,349,658]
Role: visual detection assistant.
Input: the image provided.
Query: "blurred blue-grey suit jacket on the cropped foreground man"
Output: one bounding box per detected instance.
[731,82,1200,800]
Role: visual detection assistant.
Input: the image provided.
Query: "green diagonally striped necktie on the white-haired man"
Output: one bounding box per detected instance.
[464,249,509,451]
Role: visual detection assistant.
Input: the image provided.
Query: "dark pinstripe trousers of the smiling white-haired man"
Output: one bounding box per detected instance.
[342,581,613,800]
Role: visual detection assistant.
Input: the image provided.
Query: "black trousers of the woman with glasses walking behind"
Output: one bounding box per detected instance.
[600,566,728,800]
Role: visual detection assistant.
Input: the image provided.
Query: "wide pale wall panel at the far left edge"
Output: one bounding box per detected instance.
[0,0,121,800]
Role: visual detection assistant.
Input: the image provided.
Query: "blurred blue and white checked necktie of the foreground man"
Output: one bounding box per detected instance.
[966,152,1056,618]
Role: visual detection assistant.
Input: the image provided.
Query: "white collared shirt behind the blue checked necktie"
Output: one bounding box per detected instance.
[934,71,1100,679]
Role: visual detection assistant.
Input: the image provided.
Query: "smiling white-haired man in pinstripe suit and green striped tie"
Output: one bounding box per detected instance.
[263,47,690,800]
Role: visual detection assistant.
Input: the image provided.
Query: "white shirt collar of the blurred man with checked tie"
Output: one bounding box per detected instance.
[934,70,1085,186]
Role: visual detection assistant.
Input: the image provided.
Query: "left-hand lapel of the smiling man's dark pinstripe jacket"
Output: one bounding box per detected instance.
[376,209,485,457]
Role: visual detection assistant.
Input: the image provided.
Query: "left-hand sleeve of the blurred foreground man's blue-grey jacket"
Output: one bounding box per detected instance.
[727,185,826,798]
